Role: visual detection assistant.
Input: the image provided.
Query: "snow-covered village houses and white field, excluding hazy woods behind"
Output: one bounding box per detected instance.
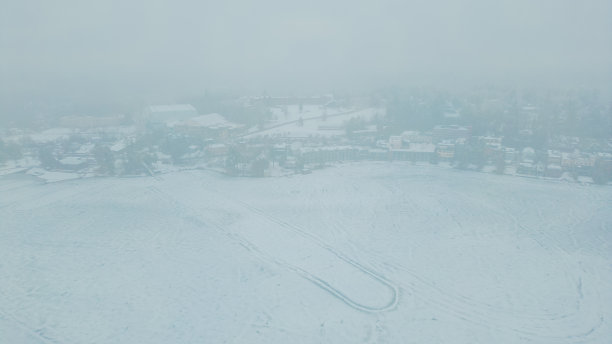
[0,95,612,184]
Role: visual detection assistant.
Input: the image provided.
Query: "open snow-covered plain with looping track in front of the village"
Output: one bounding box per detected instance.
[0,163,612,344]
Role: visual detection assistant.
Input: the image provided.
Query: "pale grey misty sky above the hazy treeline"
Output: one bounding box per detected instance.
[0,0,612,96]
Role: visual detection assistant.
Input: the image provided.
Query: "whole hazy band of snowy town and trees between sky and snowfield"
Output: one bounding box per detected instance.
[2,88,612,184]
